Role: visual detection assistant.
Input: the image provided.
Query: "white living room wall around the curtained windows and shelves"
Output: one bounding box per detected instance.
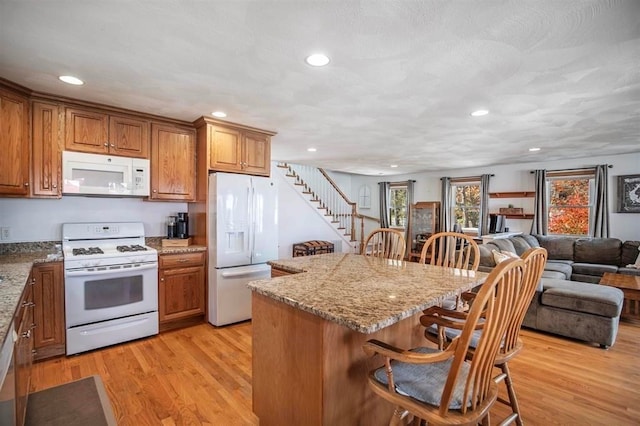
[347,152,640,241]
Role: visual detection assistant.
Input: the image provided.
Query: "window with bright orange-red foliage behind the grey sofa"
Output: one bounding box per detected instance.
[547,172,595,235]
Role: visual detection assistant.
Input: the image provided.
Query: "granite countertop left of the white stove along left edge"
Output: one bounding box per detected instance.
[0,251,62,348]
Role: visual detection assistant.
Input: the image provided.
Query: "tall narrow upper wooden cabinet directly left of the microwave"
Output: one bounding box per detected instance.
[31,101,64,197]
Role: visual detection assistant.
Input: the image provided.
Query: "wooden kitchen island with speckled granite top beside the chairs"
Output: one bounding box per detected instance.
[249,253,487,426]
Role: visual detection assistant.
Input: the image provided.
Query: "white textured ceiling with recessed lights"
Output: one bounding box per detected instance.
[0,0,640,175]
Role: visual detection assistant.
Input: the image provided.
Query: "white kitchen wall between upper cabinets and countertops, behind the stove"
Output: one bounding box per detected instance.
[0,196,187,243]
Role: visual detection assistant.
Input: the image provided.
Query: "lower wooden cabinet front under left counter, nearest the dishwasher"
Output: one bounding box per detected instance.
[13,277,34,426]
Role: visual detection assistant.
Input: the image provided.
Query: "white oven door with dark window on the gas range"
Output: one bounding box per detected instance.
[65,262,158,328]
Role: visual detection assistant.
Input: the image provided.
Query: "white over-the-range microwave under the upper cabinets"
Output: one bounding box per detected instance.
[62,151,150,197]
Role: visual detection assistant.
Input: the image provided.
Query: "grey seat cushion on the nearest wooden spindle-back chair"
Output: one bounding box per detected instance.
[374,348,471,410]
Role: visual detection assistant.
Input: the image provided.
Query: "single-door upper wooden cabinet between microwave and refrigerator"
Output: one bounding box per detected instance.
[149,123,196,201]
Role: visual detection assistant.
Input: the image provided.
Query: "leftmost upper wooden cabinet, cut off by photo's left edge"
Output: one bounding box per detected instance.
[0,88,30,196]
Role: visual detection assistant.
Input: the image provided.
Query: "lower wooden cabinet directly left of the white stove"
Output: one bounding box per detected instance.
[31,262,66,360]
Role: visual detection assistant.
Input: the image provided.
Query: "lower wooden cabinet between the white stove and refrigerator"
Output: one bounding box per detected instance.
[158,252,206,331]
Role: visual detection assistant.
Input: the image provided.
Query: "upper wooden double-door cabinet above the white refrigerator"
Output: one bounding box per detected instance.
[196,117,275,176]
